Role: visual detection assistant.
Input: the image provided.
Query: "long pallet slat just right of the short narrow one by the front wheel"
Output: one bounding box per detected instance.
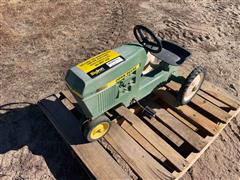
[115,106,187,170]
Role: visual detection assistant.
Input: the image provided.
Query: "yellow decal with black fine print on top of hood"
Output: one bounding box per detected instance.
[76,50,120,73]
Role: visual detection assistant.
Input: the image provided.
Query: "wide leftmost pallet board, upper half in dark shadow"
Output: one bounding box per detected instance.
[38,96,130,179]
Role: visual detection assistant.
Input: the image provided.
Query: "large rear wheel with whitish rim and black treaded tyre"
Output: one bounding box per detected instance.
[178,67,206,104]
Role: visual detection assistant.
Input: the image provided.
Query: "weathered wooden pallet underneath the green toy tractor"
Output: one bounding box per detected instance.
[38,81,240,179]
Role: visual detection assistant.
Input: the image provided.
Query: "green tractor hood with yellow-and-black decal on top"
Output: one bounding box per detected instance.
[65,44,146,98]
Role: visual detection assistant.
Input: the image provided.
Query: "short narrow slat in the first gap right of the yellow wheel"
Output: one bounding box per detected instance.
[120,120,166,162]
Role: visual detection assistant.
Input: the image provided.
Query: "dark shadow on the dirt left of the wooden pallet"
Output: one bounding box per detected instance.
[0,102,87,179]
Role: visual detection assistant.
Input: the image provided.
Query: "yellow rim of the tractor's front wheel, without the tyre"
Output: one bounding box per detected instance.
[90,122,109,140]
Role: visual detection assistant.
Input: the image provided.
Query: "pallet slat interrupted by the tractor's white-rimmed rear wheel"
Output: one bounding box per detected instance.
[166,81,230,122]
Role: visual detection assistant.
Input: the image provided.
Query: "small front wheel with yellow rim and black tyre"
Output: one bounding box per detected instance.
[83,115,111,142]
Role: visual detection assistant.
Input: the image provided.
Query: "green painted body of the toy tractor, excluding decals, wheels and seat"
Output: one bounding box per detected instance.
[65,44,177,119]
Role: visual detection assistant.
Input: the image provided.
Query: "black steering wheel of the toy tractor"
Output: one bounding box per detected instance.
[133,25,162,53]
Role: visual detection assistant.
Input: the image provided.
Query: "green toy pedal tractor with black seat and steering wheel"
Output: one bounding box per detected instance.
[66,25,205,141]
